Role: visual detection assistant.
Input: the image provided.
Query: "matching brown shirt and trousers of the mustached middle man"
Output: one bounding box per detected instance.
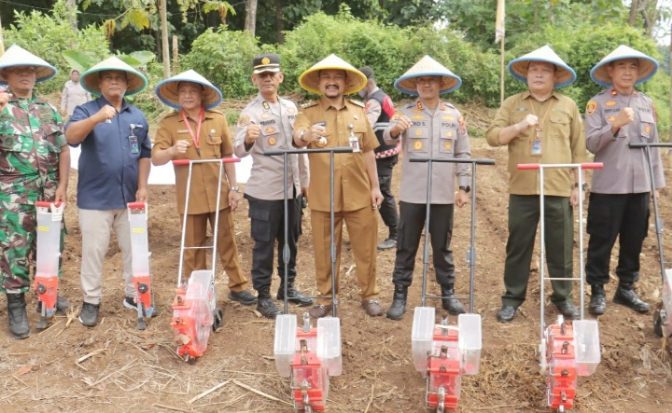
[294,97,379,305]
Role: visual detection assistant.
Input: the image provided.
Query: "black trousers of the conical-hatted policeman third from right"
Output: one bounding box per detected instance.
[392,202,455,287]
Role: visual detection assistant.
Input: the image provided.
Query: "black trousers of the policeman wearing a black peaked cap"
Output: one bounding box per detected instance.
[245,195,301,291]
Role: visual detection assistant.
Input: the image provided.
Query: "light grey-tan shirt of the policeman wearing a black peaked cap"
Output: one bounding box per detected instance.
[233,94,310,201]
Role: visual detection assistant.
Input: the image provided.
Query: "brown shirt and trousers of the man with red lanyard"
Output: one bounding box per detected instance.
[152,110,248,292]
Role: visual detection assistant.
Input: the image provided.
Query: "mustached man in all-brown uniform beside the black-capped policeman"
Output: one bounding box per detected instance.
[294,55,383,318]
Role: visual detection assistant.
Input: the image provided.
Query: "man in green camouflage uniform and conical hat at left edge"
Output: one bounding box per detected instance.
[0,45,70,338]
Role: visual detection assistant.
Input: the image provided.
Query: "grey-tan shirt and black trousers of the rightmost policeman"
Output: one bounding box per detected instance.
[586,88,665,285]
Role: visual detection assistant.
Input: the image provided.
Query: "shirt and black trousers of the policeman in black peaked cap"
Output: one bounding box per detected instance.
[234,94,309,290]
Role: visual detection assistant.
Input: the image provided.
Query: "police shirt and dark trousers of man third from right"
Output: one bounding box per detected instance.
[383,99,471,287]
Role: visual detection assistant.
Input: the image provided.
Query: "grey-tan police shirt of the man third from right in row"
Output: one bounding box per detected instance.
[383,99,471,204]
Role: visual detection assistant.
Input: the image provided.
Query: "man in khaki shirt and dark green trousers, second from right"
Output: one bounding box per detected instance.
[486,46,587,322]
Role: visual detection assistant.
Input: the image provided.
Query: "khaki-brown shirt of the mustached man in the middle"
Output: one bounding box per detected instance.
[294,97,379,212]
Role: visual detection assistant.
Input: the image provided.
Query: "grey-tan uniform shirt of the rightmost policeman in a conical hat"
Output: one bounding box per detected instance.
[586,89,665,194]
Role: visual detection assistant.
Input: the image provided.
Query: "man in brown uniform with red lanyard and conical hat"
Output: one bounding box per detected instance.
[152,70,257,305]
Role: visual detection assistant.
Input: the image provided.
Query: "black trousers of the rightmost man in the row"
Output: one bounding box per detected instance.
[586,192,651,285]
